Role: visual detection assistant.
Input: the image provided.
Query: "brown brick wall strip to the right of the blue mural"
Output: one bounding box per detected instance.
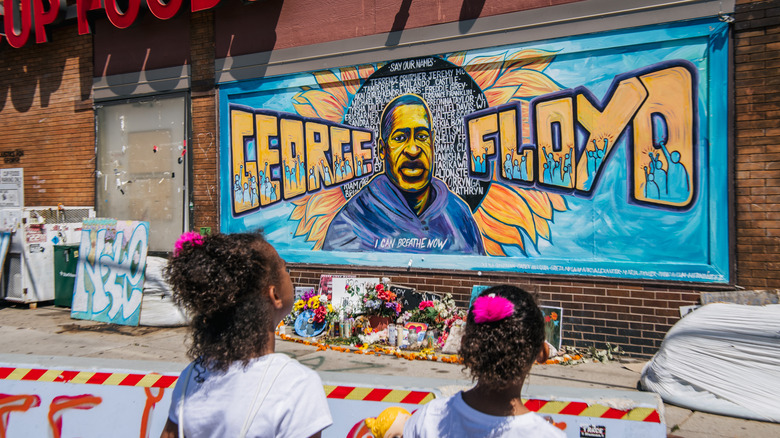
[734,0,780,289]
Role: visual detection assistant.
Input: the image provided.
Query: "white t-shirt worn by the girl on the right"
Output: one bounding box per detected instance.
[404,392,566,438]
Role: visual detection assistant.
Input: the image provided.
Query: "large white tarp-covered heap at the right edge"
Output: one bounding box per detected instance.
[641,303,780,423]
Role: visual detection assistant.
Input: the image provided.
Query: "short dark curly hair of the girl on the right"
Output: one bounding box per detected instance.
[460,285,544,387]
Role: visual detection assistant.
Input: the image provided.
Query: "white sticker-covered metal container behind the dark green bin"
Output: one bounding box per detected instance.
[0,207,95,305]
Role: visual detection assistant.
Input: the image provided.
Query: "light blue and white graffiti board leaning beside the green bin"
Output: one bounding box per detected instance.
[71,219,149,325]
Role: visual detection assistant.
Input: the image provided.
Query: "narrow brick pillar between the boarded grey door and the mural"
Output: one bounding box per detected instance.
[190,11,219,231]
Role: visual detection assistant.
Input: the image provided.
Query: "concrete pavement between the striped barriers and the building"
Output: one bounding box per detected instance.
[0,302,780,438]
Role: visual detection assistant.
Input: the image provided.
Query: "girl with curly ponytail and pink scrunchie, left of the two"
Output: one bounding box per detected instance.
[161,233,333,438]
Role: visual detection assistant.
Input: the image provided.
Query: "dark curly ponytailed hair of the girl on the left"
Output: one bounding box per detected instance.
[164,232,282,370]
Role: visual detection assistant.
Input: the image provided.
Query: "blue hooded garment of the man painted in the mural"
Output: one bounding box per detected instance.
[323,174,485,255]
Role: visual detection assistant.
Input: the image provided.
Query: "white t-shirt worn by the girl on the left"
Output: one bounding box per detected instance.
[168,353,333,438]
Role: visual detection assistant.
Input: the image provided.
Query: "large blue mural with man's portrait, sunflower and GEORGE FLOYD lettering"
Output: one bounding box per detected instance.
[220,19,729,282]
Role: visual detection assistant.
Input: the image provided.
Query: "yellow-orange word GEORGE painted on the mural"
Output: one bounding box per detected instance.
[230,106,375,210]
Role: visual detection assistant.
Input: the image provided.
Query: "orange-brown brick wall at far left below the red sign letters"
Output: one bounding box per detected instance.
[0,27,95,207]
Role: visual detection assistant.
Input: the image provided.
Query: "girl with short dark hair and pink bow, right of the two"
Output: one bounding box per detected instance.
[404,285,566,438]
